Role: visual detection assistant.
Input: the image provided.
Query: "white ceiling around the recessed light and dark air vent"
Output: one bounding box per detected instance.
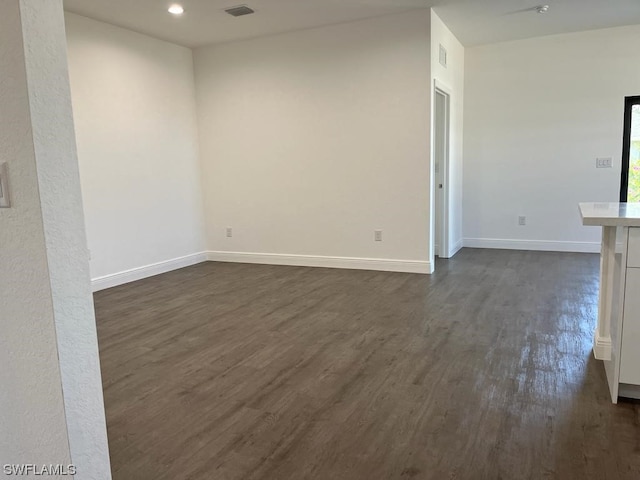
[64,0,640,48]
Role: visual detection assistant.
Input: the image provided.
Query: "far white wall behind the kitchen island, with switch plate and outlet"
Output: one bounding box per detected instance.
[464,26,640,251]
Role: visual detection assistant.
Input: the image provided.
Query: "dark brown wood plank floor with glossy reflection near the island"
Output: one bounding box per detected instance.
[95,249,640,480]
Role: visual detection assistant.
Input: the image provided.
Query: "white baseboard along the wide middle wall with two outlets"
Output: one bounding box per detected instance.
[207,252,433,274]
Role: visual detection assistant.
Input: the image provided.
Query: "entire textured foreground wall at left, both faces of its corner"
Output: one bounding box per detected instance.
[0,0,111,480]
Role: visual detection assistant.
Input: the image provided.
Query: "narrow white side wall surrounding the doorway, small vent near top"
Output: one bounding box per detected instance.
[431,10,464,257]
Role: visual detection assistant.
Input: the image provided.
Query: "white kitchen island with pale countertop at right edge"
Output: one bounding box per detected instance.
[579,203,640,403]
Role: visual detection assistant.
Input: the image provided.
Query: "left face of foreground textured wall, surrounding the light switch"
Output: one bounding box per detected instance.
[0,0,70,470]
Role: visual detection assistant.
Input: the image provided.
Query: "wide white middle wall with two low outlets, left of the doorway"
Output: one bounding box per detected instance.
[195,10,430,271]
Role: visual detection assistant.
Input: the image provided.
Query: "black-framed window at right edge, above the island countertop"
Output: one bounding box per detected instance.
[620,96,640,202]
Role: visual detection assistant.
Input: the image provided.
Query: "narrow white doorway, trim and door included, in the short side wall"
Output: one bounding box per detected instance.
[433,83,451,258]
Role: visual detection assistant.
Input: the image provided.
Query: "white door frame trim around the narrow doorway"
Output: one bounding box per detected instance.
[431,79,453,260]
